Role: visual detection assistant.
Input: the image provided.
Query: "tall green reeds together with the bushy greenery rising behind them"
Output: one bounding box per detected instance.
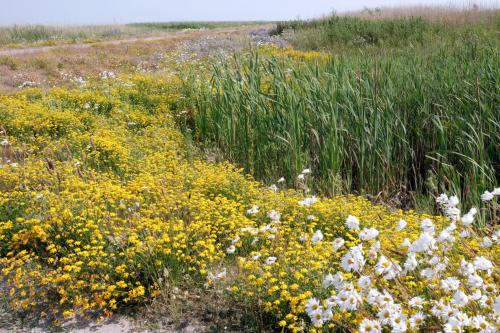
[188,14,500,219]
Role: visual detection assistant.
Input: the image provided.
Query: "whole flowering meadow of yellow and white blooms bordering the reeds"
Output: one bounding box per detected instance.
[0,14,500,333]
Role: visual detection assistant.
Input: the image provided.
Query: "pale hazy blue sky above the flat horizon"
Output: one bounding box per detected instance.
[0,0,492,25]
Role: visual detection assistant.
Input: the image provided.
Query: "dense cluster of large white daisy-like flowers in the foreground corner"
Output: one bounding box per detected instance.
[305,188,500,333]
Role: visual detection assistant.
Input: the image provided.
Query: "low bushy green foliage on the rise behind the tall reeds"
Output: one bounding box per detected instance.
[274,14,500,53]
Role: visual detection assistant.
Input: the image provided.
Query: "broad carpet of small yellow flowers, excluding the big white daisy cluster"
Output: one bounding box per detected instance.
[0,67,498,332]
